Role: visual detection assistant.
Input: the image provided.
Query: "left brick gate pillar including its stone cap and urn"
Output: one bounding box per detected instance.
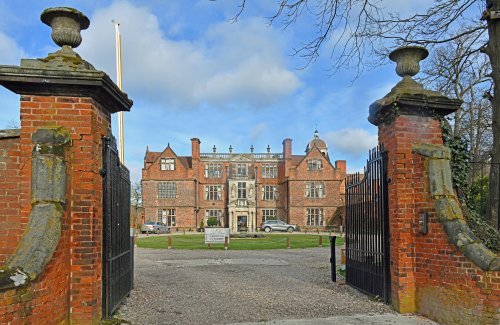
[0,8,132,324]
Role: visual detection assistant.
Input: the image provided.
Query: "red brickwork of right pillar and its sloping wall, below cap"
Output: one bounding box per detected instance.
[379,112,500,324]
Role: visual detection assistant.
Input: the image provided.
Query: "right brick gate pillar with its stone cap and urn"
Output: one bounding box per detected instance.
[368,47,461,313]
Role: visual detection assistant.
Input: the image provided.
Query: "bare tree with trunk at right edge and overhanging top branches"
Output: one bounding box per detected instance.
[228,0,500,228]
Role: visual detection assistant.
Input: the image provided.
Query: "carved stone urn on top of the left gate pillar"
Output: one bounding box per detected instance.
[40,7,90,48]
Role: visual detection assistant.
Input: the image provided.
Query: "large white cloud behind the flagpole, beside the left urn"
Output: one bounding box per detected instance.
[77,2,300,107]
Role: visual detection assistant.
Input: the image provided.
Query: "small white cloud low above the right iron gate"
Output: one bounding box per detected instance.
[324,128,378,159]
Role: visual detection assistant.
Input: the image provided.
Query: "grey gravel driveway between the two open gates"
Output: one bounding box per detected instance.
[118,248,414,324]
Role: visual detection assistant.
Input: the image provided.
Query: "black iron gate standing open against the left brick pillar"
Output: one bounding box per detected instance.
[102,133,134,318]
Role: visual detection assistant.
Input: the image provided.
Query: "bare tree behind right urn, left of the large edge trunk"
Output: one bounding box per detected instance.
[420,35,492,161]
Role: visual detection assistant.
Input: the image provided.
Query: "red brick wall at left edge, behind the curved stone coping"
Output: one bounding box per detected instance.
[0,136,21,265]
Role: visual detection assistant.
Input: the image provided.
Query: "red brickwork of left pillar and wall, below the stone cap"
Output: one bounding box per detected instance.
[0,96,110,324]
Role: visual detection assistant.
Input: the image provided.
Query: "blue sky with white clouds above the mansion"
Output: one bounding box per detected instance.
[0,0,429,182]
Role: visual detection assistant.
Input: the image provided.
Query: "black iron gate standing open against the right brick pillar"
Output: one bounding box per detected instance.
[346,147,390,302]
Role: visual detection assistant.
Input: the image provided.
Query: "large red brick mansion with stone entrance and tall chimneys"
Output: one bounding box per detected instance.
[142,131,346,232]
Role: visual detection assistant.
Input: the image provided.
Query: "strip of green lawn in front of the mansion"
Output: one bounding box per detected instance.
[137,234,344,250]
